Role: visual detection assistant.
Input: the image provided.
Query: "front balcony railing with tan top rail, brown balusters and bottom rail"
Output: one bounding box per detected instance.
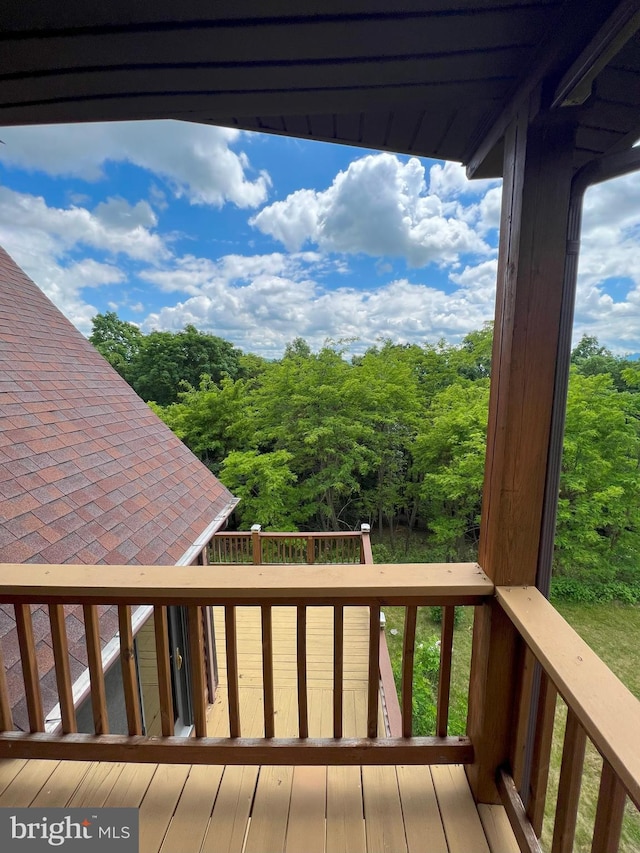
[0,563,493,765]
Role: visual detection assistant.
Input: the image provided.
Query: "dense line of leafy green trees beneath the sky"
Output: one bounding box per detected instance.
[90,313,640,600]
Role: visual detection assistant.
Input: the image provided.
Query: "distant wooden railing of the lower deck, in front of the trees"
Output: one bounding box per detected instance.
[209,525,373,565]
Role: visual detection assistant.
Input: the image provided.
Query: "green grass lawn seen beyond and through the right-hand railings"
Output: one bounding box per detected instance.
[385,603,640,853]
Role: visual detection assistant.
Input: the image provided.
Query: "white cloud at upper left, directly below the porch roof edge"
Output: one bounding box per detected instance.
[0,121,270,208]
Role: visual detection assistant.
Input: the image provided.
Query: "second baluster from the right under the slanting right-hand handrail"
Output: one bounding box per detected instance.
[551,708,587,853]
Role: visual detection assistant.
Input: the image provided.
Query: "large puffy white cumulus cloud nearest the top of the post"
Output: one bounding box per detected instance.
[250,154,491,267]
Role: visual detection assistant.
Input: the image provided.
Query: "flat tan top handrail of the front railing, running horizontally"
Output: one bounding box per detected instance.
[0,563,493,606]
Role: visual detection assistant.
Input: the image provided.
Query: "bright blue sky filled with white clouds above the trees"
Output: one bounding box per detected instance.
[0,122,640,357]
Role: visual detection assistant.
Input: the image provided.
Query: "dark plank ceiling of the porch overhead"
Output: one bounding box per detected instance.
[0,0,640,174]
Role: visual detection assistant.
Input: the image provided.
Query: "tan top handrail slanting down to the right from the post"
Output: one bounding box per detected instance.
[496,587,640,808]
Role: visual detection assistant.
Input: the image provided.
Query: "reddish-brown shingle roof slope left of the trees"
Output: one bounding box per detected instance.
[0,250,235,565]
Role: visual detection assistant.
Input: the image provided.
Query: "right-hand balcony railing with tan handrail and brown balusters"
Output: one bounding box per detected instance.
[496,587,640,853]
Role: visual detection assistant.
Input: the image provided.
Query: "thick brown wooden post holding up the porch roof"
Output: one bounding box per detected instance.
[468,105,574,803]
